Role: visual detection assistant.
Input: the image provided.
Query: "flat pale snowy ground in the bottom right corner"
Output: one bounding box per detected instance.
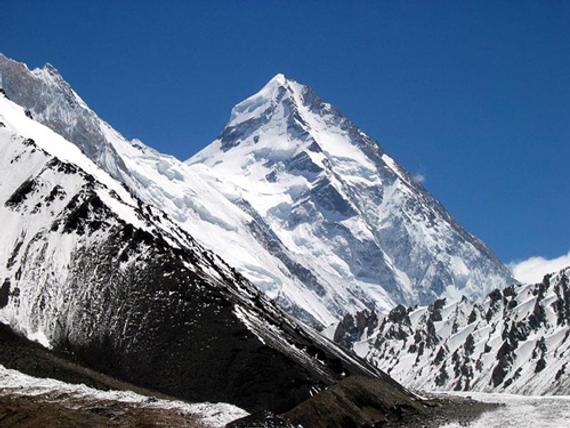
[437,392,570,428]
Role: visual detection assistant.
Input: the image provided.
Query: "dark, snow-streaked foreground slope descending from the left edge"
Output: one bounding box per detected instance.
[0,89,399,410]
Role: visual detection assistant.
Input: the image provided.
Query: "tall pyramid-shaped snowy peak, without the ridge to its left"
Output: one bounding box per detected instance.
[188,74,514,319]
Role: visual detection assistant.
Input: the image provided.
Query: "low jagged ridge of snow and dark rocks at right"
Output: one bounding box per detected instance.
[334,268,570,394]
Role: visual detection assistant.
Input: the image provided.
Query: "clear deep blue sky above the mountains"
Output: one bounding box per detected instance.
[0,0,570,261]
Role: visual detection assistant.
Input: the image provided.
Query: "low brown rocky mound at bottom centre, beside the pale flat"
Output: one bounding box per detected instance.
[228,376,497,428]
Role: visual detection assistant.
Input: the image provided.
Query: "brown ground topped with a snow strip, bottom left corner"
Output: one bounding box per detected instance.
[0,365,247,428]
